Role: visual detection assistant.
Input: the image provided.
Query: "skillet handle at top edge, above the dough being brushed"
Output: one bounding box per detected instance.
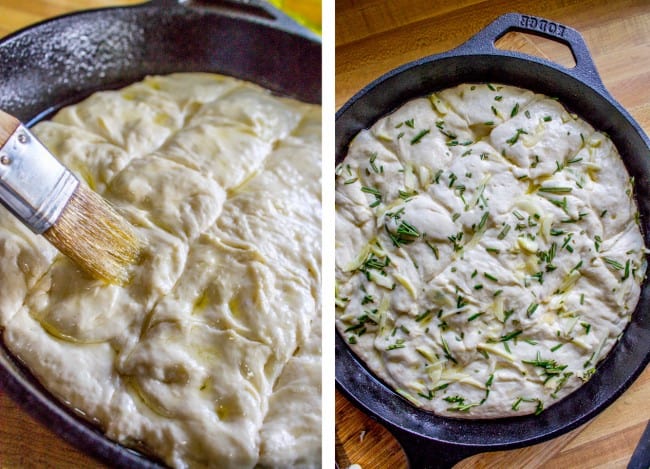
[148,0,321,42]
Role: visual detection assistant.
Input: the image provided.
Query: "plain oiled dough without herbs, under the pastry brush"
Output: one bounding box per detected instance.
[0,74,321,468]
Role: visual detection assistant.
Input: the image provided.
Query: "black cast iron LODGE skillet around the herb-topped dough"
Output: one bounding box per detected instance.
[335,13,650,469]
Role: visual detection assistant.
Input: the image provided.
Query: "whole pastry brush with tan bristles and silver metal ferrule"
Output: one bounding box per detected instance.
[0,110,139,285]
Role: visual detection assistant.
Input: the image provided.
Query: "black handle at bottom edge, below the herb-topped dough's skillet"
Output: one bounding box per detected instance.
[386,425,484,469]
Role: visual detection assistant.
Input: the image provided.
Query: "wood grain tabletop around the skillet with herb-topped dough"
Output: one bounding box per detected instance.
[335,0,650,469]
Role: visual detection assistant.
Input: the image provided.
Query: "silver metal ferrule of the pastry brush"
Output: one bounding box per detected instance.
[0,125,79,234]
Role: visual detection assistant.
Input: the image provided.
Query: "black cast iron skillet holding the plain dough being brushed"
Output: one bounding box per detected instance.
[0,0,321,468]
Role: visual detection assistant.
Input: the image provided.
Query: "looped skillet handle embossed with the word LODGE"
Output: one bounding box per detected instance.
[454,13,606,91]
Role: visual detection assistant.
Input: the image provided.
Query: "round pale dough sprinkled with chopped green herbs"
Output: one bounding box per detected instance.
[336,84,646,418]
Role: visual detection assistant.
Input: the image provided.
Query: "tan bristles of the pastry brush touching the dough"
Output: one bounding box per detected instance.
[43,184,139,285]
